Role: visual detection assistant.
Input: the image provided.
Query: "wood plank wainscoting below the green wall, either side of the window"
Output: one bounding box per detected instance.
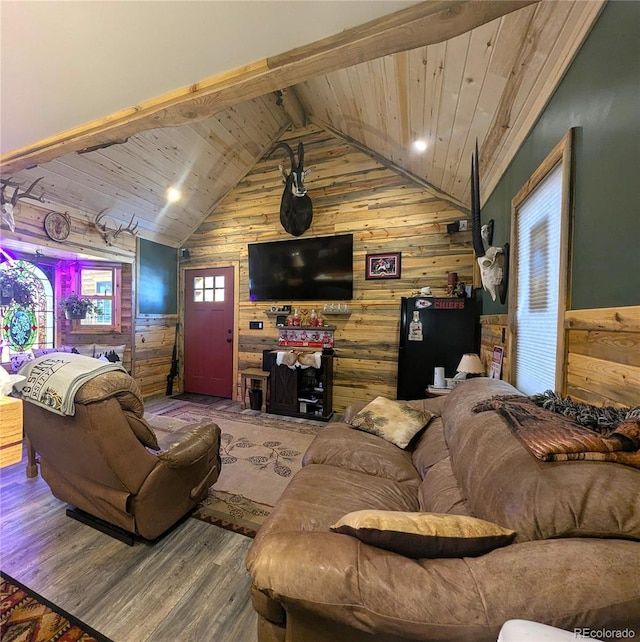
[480,306,640,406]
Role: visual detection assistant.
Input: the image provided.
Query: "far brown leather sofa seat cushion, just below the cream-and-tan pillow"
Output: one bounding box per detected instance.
[302,423,420,487]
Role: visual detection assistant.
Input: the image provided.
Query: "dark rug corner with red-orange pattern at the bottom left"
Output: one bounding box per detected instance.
[0,571,111,642]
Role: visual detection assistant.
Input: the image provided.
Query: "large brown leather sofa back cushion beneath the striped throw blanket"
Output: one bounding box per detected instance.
[442,378,640,541]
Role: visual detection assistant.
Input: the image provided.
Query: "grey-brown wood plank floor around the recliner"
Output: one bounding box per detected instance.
[0,400,272,642]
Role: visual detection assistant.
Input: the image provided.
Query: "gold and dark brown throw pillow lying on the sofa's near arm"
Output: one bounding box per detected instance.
[331,510,516,559]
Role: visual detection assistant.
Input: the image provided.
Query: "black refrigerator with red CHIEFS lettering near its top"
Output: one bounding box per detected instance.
[397,297,479,399]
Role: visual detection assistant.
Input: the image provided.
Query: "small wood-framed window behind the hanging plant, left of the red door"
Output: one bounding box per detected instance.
[73,266,120,332]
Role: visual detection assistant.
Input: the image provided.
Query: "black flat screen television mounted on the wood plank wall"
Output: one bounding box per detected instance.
[248,234,353,301]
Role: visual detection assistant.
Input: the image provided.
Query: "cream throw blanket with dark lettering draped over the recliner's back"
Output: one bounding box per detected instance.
[14,352,126,415]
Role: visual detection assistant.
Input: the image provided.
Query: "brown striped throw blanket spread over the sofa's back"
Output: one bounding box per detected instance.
[473,396,640,468]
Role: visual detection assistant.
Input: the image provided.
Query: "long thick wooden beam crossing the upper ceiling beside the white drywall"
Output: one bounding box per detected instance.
[0,0,540,175]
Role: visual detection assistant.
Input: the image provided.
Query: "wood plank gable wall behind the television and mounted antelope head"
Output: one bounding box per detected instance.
[182,126,473,411]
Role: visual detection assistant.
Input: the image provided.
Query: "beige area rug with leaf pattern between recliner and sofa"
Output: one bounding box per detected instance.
[145,399,323,537]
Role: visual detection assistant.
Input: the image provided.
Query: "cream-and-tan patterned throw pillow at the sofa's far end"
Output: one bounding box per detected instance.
[350,397,434,448]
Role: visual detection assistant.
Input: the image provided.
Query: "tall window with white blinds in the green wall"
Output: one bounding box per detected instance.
[515,162,564,394]
